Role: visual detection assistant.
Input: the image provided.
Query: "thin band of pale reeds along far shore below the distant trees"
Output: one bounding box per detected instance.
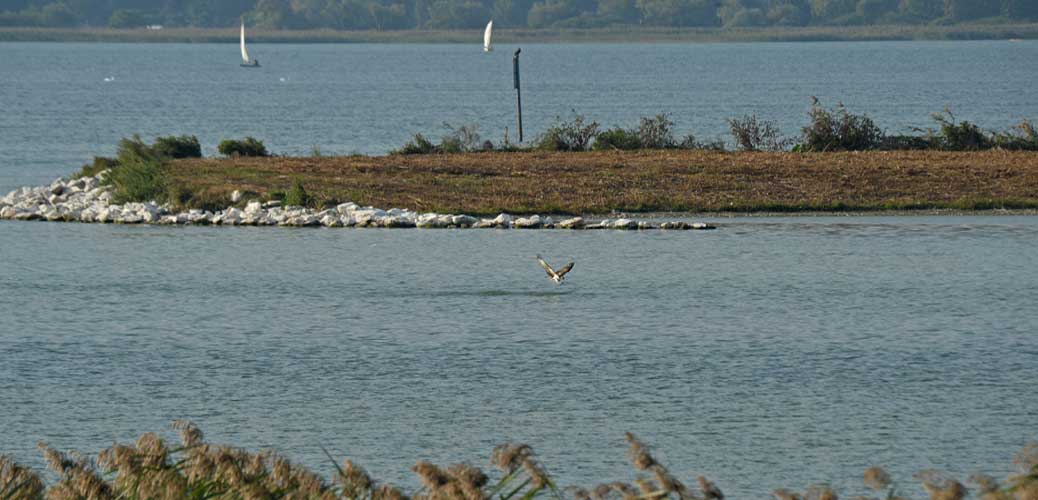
[6,23,1038,44]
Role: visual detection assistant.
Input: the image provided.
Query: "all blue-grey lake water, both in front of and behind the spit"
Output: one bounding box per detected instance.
[0,41,1038,498]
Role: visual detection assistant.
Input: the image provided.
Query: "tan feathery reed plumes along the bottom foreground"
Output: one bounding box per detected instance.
[0,421,1038,500]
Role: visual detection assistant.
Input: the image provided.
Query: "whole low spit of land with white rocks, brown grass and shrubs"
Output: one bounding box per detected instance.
[0,107,1038,229]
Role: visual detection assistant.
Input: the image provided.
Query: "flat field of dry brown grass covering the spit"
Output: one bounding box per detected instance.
[165,149,1038,215]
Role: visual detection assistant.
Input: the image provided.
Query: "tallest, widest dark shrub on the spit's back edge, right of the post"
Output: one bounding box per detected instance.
[800,98,883,151]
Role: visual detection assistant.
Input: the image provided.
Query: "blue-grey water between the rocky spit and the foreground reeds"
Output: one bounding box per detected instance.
[0,217,1038,498]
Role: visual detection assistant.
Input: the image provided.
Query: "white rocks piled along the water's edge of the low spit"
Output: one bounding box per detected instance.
[0,171,715,230]
